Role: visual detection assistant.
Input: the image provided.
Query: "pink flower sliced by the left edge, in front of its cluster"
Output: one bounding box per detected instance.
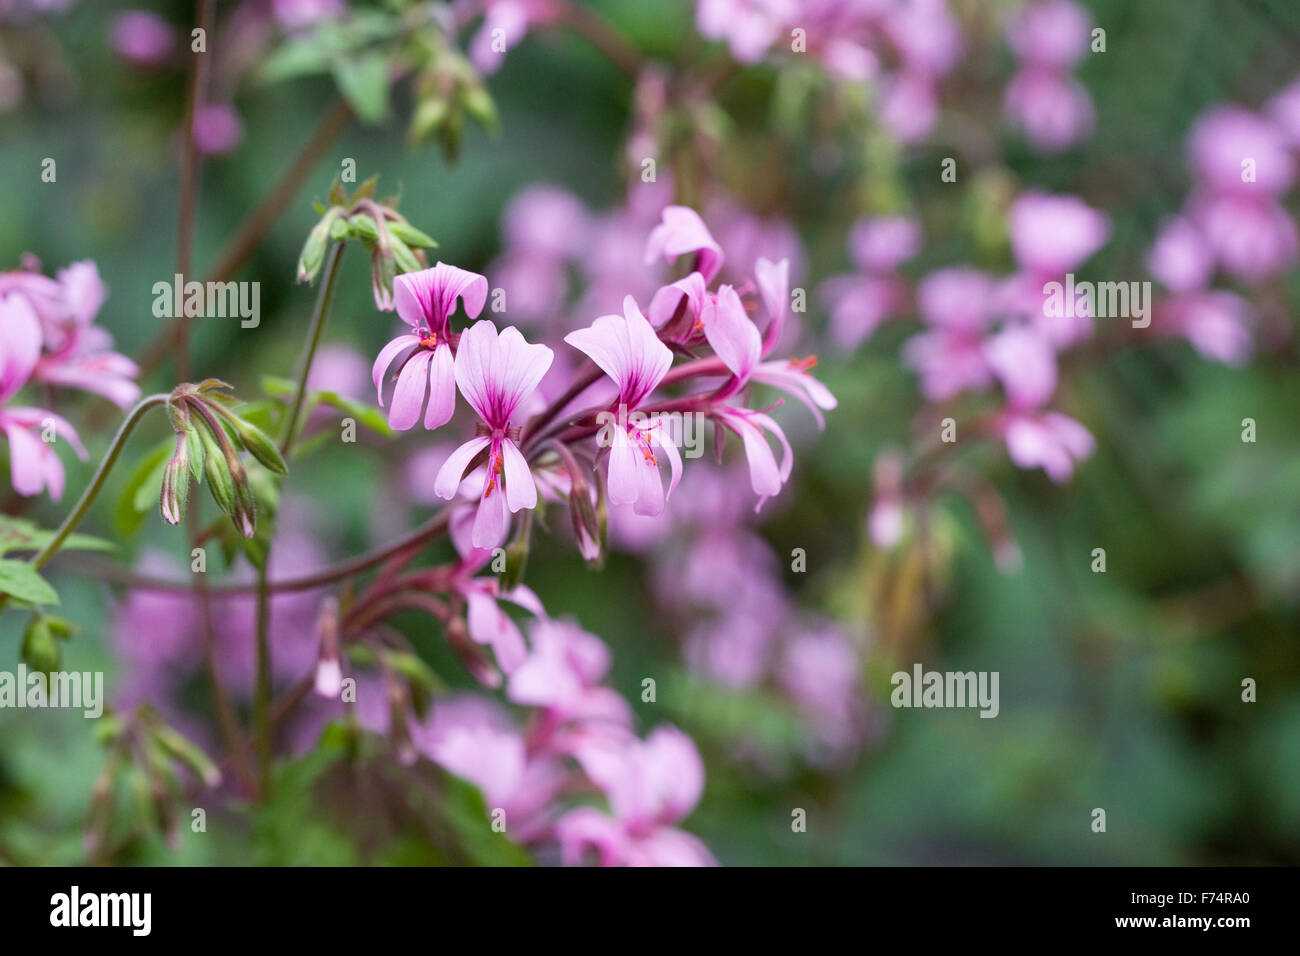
[0,294,87,501]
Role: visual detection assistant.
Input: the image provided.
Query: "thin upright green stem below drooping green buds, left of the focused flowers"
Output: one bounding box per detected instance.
[252,242,343,800]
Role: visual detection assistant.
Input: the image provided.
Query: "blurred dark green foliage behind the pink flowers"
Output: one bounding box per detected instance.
[0,0,1300,865]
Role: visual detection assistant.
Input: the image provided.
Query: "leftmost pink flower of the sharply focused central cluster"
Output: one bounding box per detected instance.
[371,263,488,431]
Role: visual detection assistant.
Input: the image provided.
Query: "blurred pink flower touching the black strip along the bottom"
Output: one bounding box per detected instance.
[555,726,716,866]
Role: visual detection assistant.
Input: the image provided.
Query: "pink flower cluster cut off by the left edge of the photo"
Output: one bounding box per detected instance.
[0,260,140,501]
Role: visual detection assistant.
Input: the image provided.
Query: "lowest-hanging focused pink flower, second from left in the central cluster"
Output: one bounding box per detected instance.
[433,319,554,548]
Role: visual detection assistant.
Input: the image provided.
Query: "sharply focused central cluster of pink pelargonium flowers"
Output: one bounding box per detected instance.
[373,206,835,561]
